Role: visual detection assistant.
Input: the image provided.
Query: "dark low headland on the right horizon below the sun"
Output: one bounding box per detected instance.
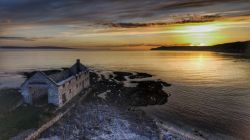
[150,41,250,56]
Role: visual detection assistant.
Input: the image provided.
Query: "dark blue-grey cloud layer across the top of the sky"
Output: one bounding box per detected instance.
[0,0,249,26]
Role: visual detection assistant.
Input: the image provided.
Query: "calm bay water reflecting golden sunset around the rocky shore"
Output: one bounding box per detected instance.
[0,51,250,139]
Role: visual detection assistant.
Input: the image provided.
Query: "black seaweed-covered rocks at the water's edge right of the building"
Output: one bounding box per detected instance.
[92,72,170,106]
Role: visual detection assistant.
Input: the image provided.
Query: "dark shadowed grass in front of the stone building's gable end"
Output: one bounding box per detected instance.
[0,89,54,140]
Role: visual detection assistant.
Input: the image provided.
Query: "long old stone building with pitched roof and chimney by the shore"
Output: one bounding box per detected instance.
[21,59,90,107]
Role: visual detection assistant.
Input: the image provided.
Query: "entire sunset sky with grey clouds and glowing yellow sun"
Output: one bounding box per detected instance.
[0,0,250,50]
